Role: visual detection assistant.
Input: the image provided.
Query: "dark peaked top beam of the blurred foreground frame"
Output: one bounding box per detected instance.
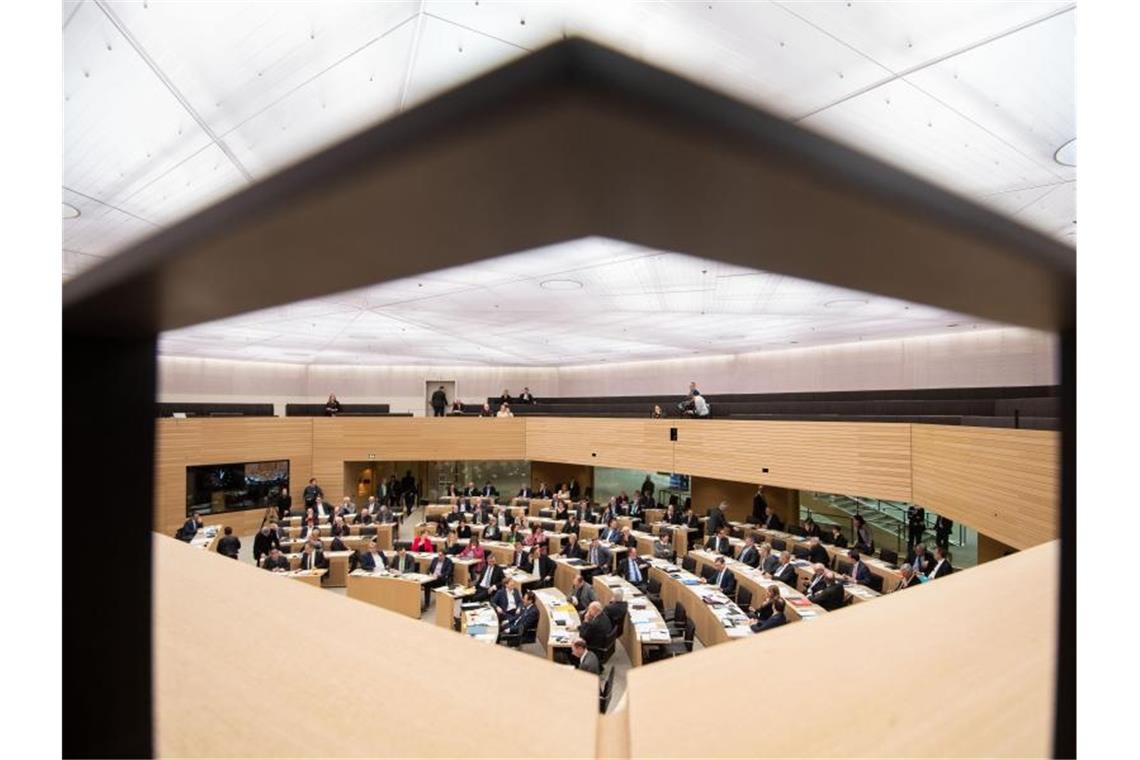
[64,40,1075,334]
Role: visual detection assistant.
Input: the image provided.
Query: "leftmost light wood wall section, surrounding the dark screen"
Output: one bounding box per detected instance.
[154,417,312,536]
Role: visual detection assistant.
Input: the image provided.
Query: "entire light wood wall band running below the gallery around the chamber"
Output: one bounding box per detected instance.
[155,417,1060,549]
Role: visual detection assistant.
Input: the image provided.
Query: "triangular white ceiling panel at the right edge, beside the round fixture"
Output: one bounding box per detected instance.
[906,13,1076,179]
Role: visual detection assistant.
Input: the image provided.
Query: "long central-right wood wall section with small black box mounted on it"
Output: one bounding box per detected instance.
[527,417,911,500]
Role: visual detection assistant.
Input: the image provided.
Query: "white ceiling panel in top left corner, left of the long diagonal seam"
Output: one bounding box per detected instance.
[64,1,210,205]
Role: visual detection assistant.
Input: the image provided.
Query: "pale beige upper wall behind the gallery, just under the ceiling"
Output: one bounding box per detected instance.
[158,328,1058,415]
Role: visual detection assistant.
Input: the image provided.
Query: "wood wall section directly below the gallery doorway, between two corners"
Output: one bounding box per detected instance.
[312,417,527,501]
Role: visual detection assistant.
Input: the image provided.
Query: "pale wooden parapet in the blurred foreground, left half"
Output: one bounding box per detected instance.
[152,536,597,758]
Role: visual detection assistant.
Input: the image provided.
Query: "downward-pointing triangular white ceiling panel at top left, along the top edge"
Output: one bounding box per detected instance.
[113,0,420,134]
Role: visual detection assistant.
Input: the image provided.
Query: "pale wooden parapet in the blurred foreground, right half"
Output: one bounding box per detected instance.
[627,541,1059,758]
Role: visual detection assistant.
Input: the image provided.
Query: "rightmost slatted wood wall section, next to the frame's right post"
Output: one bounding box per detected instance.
[912,425,1060,549]
